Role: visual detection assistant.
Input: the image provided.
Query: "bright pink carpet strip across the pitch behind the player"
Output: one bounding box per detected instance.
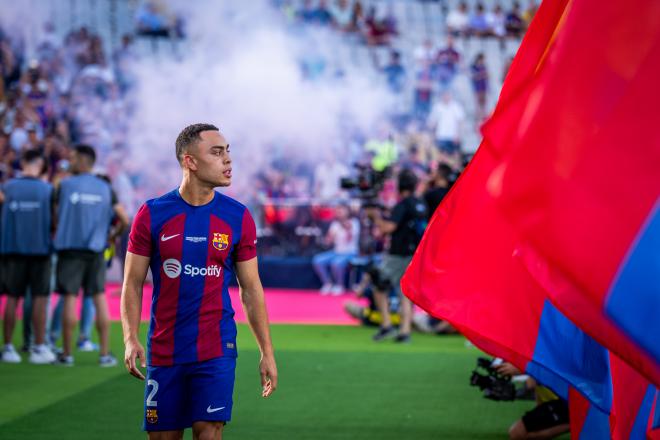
[0,284,366,325]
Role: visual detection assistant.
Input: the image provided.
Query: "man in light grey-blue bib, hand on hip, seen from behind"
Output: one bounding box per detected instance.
[53,145,128,367]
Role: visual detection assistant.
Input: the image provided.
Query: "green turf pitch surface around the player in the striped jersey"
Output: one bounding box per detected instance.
[0,323,533,440]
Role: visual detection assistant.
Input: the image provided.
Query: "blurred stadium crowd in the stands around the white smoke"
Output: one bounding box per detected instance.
[0,0,535,354]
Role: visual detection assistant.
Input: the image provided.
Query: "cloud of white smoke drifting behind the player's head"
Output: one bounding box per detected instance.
[128,0,393,199]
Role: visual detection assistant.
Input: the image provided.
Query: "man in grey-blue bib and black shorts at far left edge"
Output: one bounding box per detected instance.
[0,150,55,364]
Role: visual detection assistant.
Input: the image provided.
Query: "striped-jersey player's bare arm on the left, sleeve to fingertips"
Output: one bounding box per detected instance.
[121,252,149,379]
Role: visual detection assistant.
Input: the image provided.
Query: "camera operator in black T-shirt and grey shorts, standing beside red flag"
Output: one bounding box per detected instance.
[366,169,426,343]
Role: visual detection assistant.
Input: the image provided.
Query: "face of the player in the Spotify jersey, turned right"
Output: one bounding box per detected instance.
[190,130,231,187]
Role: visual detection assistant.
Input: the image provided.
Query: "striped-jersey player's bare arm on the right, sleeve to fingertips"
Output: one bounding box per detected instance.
[236,257,277,397]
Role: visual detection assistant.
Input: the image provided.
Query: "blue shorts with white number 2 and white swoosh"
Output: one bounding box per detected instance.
[143,357,236,431]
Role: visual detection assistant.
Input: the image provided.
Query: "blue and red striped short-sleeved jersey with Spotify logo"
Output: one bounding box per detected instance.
[128,189,257,366]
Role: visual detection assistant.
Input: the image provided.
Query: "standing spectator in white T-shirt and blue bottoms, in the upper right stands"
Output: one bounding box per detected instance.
[428,90,465,156]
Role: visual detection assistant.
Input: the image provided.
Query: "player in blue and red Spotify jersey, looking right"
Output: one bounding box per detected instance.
[121,124,277,439]
